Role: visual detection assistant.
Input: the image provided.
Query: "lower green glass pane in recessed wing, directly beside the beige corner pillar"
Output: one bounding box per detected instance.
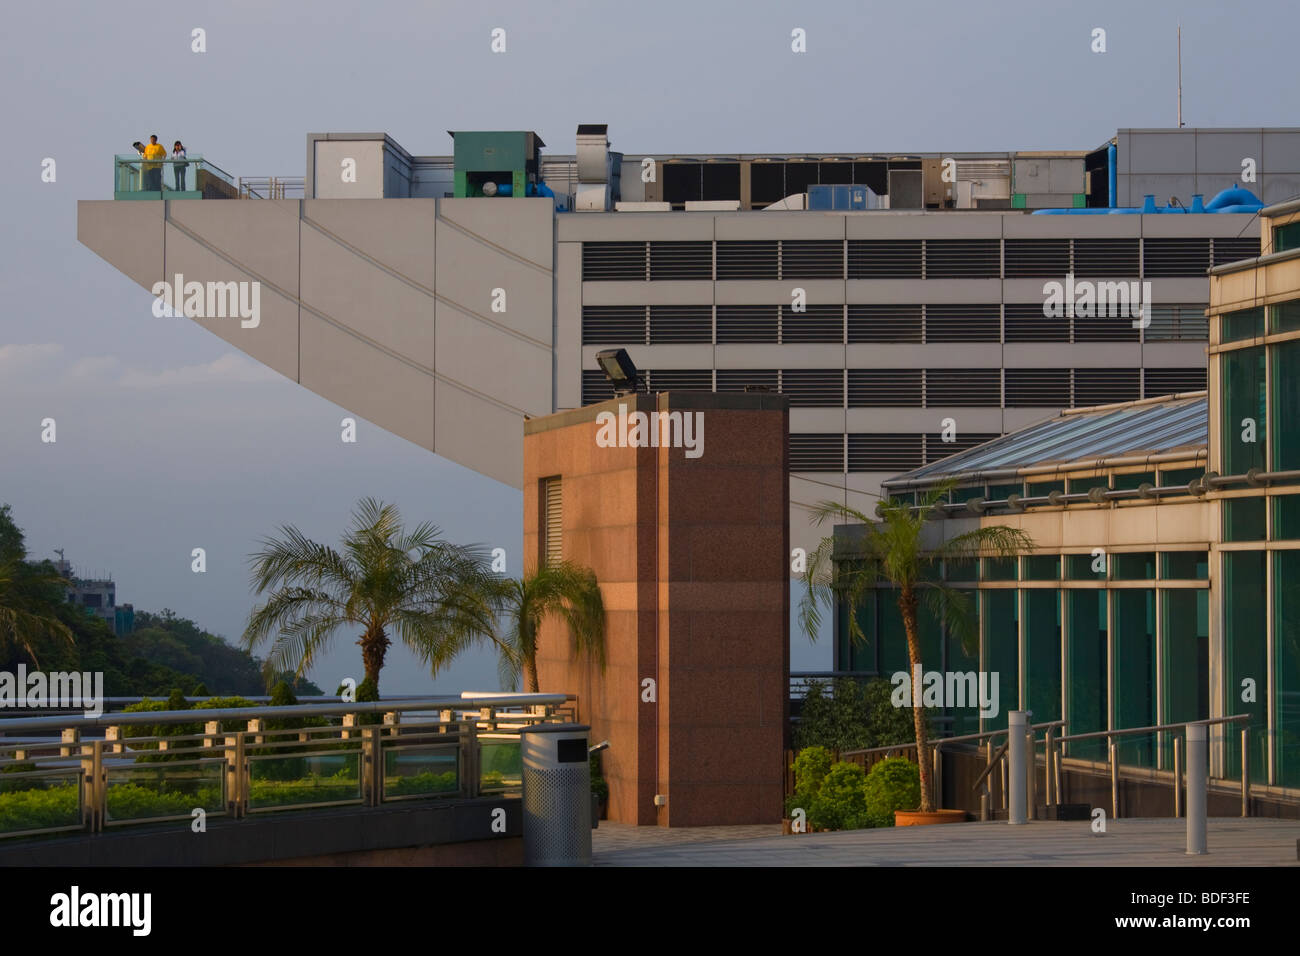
[1160,588,1210,767]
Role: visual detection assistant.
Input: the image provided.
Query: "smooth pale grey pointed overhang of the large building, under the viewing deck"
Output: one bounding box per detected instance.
[78,197,554,488]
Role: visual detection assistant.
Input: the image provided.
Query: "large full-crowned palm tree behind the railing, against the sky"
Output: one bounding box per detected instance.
[243,498,503,700]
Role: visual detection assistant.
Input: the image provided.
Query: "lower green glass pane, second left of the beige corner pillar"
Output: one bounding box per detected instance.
[1110,588,1157,767]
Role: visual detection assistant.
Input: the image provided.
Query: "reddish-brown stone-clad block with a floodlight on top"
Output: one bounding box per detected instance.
[524,393,789,826]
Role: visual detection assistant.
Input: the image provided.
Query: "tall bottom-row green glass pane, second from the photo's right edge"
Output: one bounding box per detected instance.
[1222,551,1269,782]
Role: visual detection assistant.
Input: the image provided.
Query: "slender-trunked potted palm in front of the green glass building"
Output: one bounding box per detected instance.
[800,481,1034,812]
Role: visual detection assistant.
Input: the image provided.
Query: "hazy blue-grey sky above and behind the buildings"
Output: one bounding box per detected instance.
[0,0,1300,693]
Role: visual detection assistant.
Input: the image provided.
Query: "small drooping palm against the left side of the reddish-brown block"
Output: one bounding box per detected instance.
[498,561,605,693]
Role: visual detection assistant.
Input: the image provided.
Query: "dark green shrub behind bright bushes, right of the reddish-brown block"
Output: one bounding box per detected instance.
[794,678,933,752]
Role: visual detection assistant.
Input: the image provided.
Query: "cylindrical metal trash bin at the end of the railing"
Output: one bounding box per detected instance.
[519,723,592,866]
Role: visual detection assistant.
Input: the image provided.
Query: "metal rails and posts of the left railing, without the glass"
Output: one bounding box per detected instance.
[0,693,568,839]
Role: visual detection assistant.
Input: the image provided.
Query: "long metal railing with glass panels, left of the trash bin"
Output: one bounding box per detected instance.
[0,693,572,838]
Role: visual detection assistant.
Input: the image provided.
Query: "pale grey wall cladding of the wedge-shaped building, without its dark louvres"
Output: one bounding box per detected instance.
[78,197,1258,548]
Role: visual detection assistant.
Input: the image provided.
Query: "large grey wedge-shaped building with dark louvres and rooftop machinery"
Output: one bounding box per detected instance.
[78,124,1300,548]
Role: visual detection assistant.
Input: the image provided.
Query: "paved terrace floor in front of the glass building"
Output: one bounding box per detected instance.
[592,817,1300,866]
